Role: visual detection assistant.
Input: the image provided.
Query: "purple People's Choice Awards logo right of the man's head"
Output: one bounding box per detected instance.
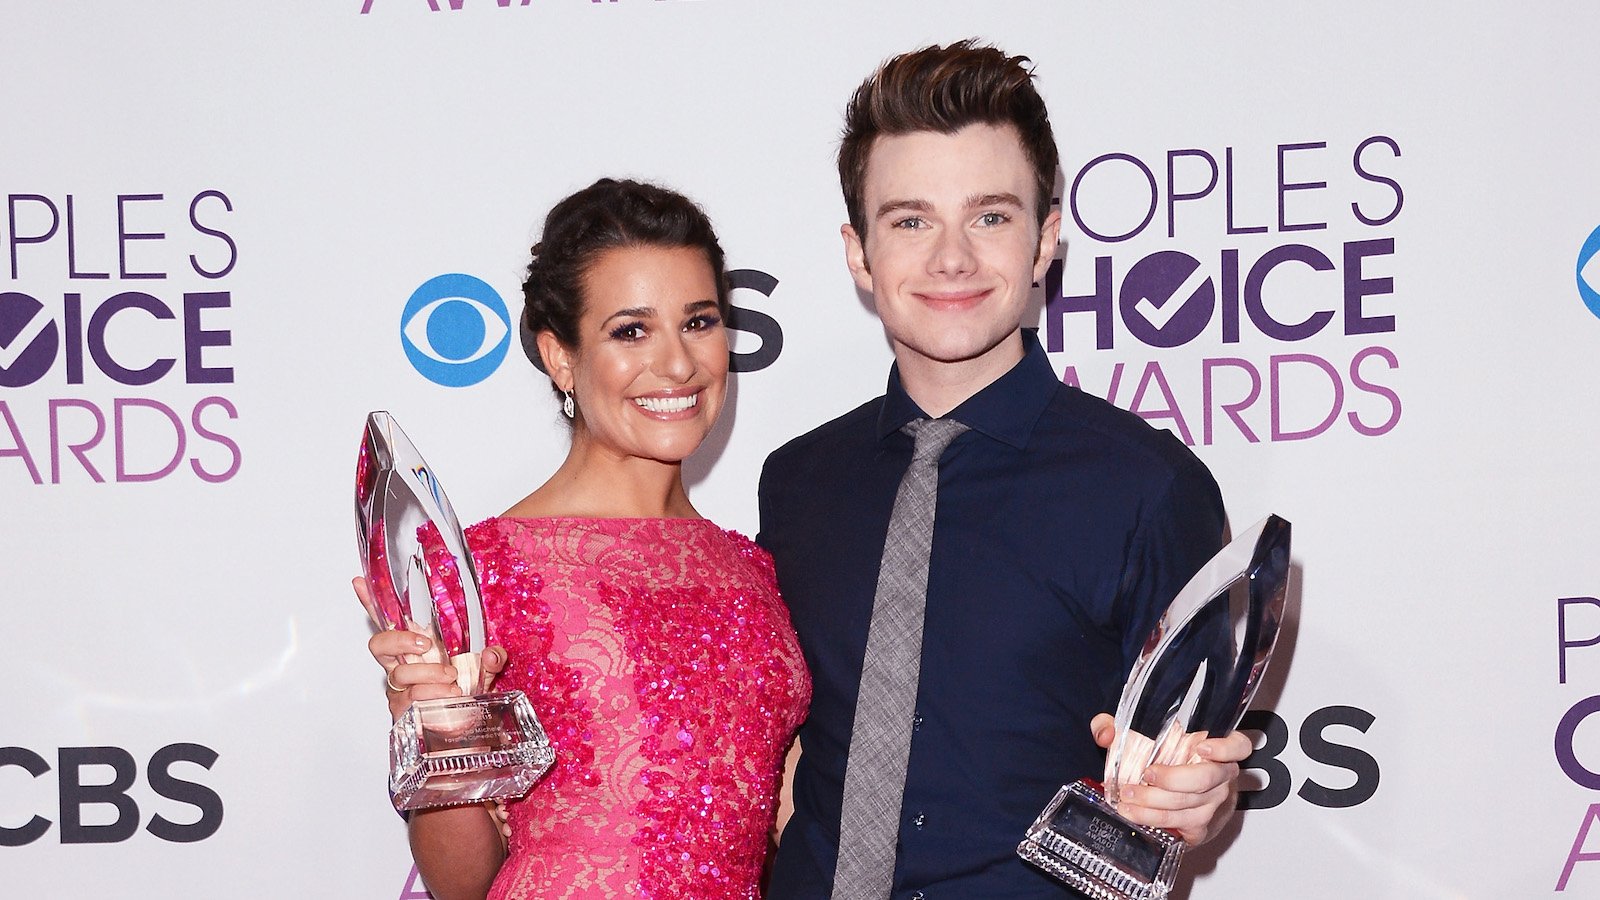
[1040,135,1414,445]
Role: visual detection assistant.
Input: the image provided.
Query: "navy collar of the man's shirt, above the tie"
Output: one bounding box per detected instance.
[878,328,1061,450]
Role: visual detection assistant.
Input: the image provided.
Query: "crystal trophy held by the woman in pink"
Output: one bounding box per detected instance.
[355,412,555,809]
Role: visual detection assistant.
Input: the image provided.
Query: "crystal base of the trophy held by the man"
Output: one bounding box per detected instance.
[1016,780,1184,900]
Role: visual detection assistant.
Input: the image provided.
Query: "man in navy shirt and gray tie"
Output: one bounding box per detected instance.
[760,42,1250,900]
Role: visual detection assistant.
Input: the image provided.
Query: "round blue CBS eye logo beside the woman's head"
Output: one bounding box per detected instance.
[400,272,510,388]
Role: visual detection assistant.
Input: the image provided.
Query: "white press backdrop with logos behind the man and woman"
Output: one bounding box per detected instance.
[0,0,1600,900]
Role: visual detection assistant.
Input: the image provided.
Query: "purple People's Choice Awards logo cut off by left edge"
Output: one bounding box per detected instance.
[0,189,243,485]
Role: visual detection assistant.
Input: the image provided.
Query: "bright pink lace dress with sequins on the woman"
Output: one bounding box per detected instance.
[467,517,811,900]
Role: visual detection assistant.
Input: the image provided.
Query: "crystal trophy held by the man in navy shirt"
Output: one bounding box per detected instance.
[1016,516,1290,900]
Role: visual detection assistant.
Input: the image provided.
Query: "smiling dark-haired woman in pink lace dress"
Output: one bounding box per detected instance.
[357,179,810,900]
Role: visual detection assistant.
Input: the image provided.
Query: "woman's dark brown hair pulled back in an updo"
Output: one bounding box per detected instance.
[522,178,728,394]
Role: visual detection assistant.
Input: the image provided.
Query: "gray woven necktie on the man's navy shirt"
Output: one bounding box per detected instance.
[834,420,966,900]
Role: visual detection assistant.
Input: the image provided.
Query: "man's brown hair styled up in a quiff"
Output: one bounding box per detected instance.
[838,38,1059,240]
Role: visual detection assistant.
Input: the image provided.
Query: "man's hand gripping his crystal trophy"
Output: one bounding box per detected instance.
[1090,713,1254,847]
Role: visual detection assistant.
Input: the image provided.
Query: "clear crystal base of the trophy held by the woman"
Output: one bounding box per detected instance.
[389,690,555,810]
